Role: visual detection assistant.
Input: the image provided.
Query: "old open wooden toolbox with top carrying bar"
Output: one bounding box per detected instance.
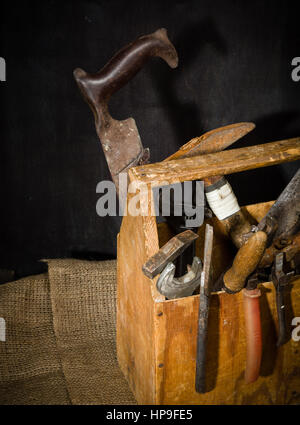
[117,139,300,404]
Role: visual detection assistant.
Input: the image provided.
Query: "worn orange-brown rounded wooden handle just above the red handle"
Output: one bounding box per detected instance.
[223,231,267,293]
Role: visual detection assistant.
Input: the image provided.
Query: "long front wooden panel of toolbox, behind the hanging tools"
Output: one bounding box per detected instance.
[156,279,300,404]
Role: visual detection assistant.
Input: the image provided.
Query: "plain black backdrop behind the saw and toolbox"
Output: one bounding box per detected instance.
[0,0,300,277]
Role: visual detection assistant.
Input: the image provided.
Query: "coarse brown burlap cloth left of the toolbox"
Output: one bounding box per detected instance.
[0,260,136,404]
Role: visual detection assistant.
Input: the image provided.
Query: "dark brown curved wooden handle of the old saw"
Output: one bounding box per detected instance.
[74,28,178,129]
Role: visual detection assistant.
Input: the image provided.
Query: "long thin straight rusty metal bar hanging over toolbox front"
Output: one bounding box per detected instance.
[195,224,213,393]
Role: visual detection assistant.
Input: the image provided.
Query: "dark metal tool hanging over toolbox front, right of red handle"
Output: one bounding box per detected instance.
[271,252,295,347]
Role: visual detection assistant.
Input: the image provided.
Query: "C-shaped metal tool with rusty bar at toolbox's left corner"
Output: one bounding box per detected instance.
[142,230,202,299]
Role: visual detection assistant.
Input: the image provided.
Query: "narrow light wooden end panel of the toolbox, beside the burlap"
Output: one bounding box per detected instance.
[117,188,165,404]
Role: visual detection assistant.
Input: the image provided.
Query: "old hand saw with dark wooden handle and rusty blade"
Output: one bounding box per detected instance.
[74,28,178,196]
